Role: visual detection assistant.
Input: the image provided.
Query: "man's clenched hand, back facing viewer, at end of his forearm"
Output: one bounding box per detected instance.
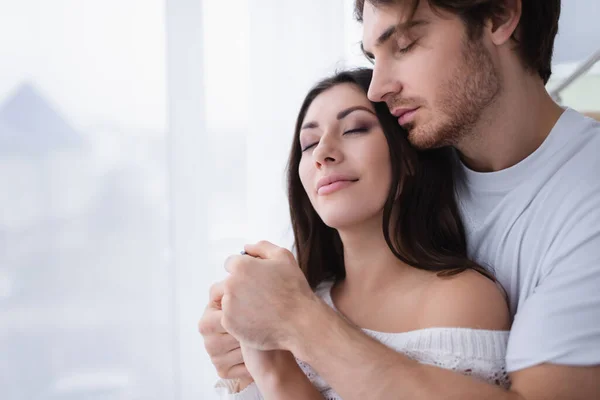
[222,242,319,350]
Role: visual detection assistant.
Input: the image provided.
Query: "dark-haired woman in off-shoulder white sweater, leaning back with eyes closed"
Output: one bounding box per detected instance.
[218,69,510,399]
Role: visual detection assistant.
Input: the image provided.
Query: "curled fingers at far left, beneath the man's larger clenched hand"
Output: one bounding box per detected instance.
[198,282,251,381]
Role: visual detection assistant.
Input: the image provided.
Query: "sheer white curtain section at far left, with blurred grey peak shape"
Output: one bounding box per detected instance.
[0,0,176,400]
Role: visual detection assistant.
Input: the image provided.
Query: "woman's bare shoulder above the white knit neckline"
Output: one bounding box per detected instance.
[419,270,510,330]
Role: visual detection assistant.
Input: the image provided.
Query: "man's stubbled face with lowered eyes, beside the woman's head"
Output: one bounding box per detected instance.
[362,1,502,149]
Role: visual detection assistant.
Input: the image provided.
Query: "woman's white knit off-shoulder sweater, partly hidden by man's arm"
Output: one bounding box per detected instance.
[216,282,510,400]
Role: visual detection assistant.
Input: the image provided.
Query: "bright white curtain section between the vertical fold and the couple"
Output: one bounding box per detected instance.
[167,0,362,399]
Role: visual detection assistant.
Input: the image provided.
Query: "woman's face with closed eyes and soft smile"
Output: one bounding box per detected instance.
[299,83,391,230]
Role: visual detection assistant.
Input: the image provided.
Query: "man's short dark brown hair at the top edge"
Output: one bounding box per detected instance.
[354,0,560,84]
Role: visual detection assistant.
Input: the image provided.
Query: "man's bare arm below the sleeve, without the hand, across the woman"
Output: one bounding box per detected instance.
[287,282,600,400]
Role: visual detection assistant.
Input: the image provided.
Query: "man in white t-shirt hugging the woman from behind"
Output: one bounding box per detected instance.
[200,0,600,400]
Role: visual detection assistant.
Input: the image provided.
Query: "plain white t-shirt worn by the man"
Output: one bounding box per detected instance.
[457,109,600,372]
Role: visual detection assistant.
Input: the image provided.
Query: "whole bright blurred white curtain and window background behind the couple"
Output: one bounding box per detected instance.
[0,0,600,400]
